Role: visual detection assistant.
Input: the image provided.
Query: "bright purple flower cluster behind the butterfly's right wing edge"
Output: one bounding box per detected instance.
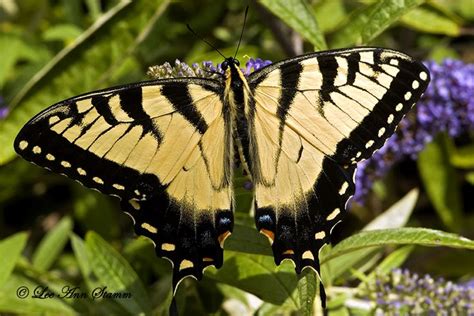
[354,59,474,203]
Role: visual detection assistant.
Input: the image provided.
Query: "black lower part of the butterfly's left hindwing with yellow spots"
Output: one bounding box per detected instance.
[122,193,233,293]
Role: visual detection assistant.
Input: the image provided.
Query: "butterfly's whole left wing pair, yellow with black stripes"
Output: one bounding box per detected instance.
[15,79,233,287]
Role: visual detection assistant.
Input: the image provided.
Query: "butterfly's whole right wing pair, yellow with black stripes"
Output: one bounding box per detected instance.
[246,48,429,272]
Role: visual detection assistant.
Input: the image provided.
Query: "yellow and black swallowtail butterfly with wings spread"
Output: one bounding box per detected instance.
[14,47,429,303]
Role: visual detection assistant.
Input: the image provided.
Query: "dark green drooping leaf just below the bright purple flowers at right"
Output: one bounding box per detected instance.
[417,134,462,231]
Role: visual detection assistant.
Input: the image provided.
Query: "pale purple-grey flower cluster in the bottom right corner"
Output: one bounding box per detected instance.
[361,269,474,315]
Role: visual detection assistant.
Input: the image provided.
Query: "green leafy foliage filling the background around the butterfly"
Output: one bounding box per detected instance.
[0,0,474,315]
